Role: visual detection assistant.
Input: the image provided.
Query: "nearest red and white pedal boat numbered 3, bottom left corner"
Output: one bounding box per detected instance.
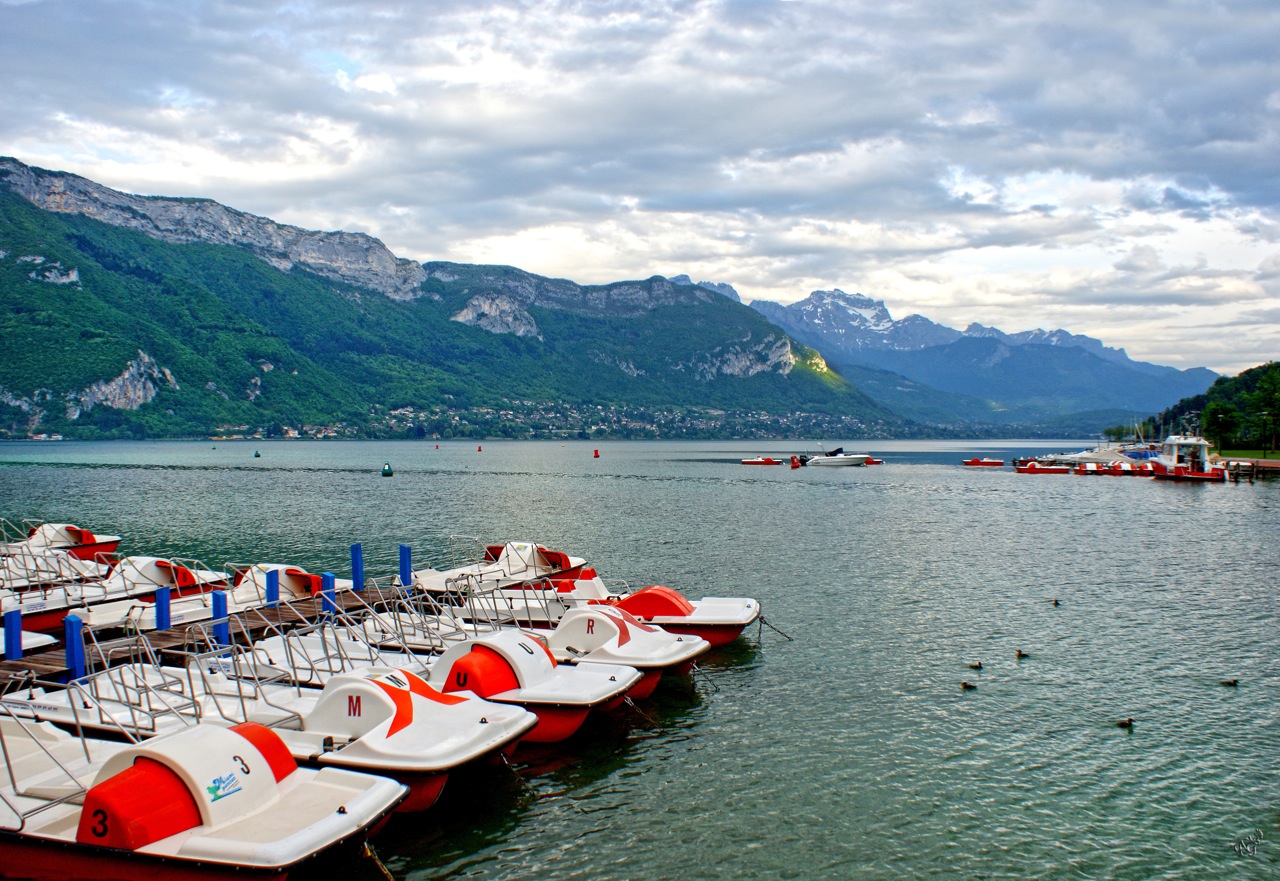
[0,702,407,881]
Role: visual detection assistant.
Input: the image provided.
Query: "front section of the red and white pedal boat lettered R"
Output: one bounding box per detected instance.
[547,606,710,698]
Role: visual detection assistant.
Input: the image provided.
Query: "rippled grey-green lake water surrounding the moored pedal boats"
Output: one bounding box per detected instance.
[0,441,1280,881]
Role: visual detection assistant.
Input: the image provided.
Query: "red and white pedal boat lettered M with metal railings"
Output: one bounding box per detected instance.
[4,638,538,811]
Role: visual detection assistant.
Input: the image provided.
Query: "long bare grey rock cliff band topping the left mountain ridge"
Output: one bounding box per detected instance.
[0,156,426,298]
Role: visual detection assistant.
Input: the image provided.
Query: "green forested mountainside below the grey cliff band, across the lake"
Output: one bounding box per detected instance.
[0,189,904,437]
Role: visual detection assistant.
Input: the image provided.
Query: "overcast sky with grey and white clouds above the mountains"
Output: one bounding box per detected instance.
[0,0,1280,373]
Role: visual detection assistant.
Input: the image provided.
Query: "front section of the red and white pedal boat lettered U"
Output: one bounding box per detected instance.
[428,625,644,743]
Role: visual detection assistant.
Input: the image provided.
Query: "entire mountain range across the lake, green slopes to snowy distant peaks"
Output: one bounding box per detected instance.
[0,158,1213,438]
